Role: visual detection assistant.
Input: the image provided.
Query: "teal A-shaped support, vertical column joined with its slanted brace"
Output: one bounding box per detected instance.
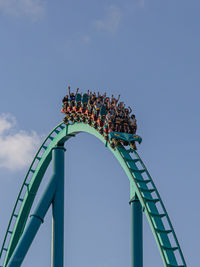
[7,147,65,267]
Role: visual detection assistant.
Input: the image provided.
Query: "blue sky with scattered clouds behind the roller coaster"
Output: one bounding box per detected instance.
[0,0,200,267]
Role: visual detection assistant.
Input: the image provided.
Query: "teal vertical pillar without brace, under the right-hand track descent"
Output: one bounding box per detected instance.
[130,196,143,267]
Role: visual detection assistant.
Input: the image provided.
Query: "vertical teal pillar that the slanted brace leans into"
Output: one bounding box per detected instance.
[51,147,65,267]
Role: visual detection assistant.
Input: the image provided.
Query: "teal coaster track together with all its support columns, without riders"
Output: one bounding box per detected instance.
[0,91,187,267]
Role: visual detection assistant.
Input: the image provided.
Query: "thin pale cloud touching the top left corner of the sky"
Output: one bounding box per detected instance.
[0,0,45,20]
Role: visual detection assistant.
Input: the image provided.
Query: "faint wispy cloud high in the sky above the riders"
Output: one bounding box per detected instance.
[94,5,121,33]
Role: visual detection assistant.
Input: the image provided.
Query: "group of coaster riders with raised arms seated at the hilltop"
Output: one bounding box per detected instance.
[61,86,137,148]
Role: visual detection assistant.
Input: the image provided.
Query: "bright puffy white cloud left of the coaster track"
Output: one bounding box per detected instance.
[0,114,41,171]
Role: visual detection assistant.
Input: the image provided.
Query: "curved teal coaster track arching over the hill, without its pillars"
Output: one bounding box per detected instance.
[0,123,187,267]
